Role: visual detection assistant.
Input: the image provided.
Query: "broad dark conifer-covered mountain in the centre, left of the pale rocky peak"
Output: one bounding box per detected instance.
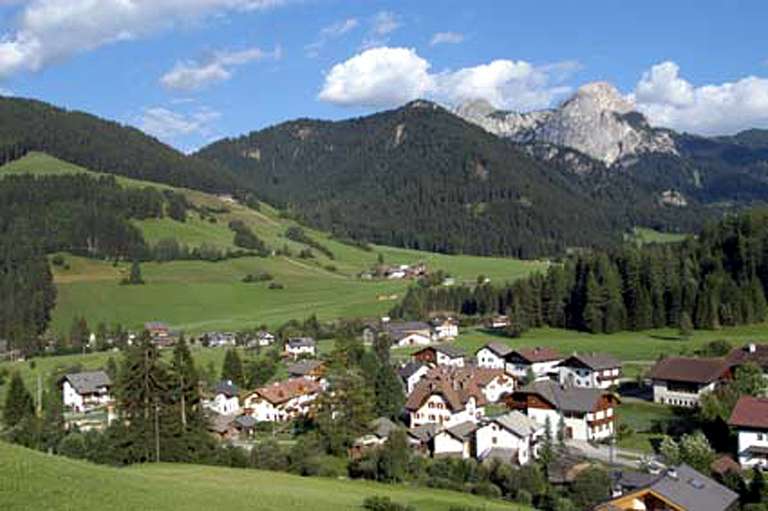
[198,101,695,257]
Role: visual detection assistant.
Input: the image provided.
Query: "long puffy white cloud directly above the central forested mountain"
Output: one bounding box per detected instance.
[318,47,570,110]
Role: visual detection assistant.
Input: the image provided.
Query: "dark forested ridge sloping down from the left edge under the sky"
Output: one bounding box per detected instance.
[0,97,238,192]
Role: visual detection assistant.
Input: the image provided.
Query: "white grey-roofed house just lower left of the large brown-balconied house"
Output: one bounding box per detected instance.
[475,410,544,465]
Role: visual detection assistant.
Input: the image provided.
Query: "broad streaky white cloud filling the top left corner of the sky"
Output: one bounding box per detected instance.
[0,0,288,76]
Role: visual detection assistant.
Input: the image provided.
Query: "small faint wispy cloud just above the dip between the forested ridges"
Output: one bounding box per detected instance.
[139,107,221,142]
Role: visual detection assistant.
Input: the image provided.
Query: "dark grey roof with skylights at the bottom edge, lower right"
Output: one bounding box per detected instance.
[650,464,739,511]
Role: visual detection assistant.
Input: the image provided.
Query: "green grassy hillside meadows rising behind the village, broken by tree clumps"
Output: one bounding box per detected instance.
[0,153,546,333]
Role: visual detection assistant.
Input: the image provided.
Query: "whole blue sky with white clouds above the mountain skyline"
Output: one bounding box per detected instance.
[0,0,768,151]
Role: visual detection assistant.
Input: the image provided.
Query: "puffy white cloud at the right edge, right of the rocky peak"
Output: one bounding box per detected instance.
[631,61,768,135]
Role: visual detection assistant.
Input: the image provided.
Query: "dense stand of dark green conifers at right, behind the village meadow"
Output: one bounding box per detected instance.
[392,209,768,335]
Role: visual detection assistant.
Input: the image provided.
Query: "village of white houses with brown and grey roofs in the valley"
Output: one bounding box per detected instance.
[51,317,768,511]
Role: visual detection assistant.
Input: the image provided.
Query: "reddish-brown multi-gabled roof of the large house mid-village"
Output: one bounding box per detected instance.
[405,367,492,411]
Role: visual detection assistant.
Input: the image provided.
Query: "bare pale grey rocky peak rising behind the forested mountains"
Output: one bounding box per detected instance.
[455,82,677,166]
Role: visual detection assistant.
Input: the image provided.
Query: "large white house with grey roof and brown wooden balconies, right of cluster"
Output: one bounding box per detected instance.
[505,380,619,441]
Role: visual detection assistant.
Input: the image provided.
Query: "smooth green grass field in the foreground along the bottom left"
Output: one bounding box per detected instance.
[0,443,529,511]
